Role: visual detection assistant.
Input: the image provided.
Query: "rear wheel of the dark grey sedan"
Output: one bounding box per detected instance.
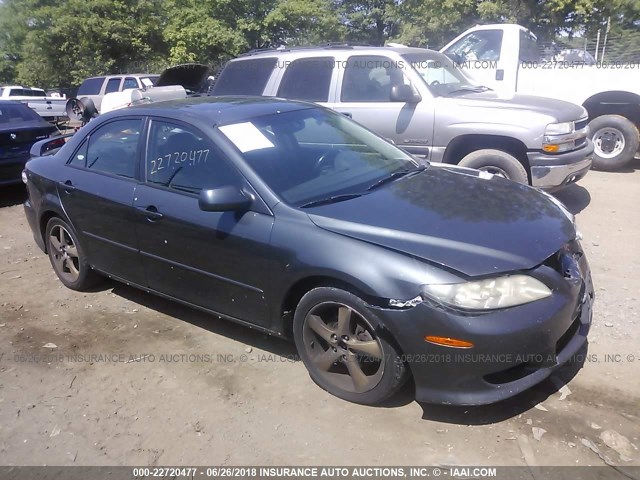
[45,217,99,290]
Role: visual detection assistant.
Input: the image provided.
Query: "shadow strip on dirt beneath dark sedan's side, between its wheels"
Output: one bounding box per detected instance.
[109,279,298,359]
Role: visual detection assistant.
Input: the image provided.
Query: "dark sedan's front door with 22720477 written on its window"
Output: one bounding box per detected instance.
[134,120,273,326]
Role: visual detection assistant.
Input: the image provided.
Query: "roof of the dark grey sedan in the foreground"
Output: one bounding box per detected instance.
[107,96,319,126]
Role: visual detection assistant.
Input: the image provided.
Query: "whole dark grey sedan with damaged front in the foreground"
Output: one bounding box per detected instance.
[25,97,593,404]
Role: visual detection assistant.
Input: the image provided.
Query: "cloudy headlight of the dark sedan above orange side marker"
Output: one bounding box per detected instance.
[422,275,551,310]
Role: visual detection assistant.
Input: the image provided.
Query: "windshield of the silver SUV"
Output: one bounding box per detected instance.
[402,53,479,97]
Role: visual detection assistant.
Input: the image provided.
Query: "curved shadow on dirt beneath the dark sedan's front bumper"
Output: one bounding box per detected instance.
[420,344,588,425]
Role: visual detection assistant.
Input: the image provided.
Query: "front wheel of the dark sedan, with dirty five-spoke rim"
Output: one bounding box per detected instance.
[293,287,408,405]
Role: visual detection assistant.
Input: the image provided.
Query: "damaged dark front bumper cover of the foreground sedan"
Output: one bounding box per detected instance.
[379,246,594,405]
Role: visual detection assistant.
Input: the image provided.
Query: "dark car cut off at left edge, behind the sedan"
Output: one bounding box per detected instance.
[0,100,56,185]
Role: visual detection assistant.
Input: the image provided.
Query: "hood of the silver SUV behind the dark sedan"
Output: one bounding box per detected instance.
[439,91,587,122]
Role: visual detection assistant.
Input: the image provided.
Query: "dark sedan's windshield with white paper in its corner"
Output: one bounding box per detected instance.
[219,108,419,207]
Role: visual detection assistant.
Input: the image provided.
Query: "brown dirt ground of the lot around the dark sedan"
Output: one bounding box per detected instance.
[0,167,640,466]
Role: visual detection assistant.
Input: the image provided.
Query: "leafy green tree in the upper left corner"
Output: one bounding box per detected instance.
[0,0,166,88]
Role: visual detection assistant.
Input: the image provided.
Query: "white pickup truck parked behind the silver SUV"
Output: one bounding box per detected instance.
[441,24,640,170]
